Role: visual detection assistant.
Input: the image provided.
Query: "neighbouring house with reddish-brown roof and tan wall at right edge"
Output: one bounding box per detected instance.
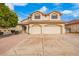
[65,19,79,33]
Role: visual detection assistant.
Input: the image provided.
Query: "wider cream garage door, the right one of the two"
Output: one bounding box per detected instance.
[42,25,61,34]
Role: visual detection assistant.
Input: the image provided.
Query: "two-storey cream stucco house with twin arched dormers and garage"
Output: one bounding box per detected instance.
[18,11,65,34]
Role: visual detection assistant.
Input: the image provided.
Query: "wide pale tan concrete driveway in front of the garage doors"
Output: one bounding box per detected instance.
[0,34,79,56]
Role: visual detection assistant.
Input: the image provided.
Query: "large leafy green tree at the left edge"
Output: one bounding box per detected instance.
[0,3,18,28]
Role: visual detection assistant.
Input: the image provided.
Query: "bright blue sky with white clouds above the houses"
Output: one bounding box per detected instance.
[6,3,79,21]
